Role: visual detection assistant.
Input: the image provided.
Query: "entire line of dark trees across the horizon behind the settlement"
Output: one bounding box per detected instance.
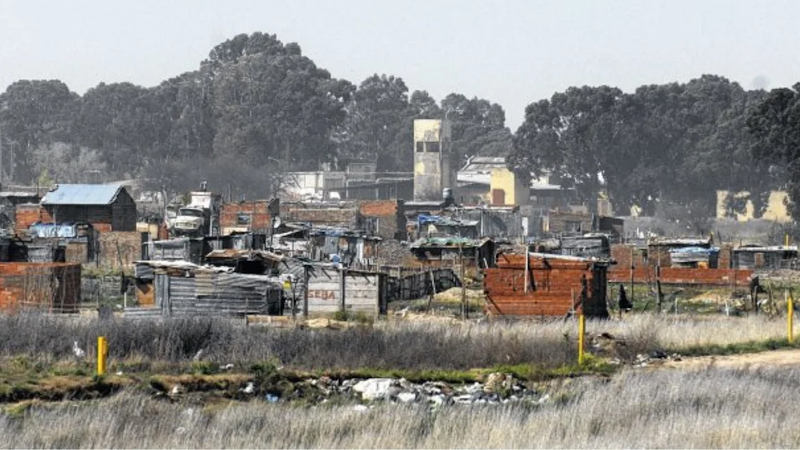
[0,29,800,217]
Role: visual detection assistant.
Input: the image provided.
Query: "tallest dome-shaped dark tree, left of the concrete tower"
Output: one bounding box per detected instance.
[209,33,352,169]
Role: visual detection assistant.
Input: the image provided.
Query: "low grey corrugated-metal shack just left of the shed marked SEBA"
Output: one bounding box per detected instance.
[125,261,283,317]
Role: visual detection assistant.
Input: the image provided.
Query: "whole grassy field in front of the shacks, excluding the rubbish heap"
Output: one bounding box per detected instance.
[0,313,800,448]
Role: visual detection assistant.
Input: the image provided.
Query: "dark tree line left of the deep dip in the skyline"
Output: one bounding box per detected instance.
[0,33,511,197]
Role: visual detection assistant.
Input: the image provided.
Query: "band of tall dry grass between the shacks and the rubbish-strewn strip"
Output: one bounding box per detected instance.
[0,314,785,370]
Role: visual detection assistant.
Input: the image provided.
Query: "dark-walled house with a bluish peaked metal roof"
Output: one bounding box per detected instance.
[40,184,136,232]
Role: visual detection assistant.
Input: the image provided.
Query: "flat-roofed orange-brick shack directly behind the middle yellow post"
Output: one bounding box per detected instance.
[484,253,609,317]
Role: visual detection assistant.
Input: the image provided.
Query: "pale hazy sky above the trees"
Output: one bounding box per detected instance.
[0,0,800,130]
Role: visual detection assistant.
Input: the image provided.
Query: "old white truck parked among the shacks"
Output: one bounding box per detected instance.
[170,191,222,237]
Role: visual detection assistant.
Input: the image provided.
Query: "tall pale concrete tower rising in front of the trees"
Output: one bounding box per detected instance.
[413,119,451,201]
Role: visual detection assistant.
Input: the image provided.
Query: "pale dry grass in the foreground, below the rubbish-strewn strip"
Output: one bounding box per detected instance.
[0,369,800,448]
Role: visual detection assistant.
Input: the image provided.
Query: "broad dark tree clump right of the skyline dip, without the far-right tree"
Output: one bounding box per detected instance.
[509,75,774,216]
